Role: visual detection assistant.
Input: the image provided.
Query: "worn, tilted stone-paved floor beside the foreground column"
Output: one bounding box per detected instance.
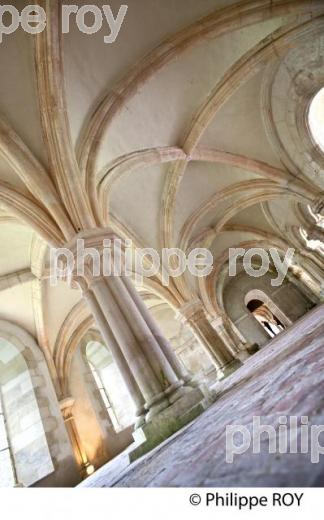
[81,305,324,487]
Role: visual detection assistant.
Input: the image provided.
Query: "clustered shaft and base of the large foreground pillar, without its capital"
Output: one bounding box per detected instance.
[80,276,210,460]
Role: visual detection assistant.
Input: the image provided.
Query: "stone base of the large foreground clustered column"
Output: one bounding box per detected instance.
[129,387,210,462]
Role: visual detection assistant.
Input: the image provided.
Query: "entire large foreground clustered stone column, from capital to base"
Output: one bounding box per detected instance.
[67,234,210,460]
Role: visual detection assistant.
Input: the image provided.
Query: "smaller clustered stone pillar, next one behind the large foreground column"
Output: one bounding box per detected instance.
[178,300,242,379]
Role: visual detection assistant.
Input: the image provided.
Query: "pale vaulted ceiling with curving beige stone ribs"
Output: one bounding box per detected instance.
[0,0,324,368]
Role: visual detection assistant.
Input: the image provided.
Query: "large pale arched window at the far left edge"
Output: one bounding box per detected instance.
[0,334,54,486]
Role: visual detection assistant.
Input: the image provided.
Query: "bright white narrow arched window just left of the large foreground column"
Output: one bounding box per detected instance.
[85,341,135,432]
